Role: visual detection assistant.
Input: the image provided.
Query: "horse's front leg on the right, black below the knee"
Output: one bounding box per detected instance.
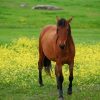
[67,63,74,95]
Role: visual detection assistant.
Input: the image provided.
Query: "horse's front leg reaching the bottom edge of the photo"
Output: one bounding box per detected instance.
[55,63,63,100]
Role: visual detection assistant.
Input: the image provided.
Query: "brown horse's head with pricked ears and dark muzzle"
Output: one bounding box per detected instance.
[56,17,72,49]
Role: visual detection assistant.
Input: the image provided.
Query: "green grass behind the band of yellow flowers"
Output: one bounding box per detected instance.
[0,0,100,43]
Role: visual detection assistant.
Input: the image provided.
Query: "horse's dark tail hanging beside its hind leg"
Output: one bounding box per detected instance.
[43,56,52,76]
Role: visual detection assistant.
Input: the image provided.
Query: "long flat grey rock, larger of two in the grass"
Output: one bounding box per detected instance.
[32,5,62,10]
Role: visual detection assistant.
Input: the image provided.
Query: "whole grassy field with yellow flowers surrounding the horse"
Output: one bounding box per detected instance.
[0,0,100,100]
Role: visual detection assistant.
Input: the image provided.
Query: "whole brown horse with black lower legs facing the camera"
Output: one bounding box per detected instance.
[38,17,75,100]
